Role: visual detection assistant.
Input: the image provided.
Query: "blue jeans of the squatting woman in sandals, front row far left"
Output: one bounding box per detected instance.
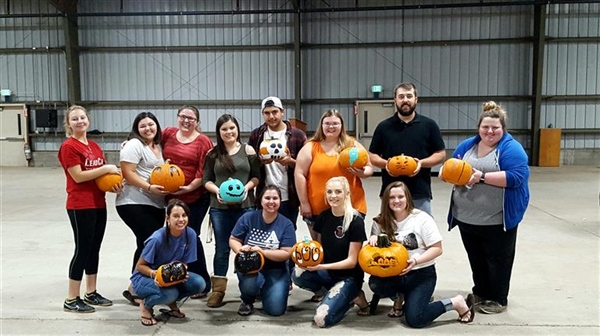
[133,272,206,309]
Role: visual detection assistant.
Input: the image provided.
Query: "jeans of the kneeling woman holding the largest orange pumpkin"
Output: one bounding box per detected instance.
[369,265,446,328]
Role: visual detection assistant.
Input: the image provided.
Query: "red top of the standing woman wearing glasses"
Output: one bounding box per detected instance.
[162,127,213,204]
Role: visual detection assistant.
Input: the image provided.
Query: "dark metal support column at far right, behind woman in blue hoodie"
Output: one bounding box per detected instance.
[530,5,546,166]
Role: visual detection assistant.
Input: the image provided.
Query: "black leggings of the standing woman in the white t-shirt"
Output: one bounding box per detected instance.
[117,204,165,273]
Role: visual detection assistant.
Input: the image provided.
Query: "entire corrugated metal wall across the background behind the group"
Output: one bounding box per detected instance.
[0,0,600,150]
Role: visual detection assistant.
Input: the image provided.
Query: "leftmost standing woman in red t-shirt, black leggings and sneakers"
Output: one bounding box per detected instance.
[58,105,121,313]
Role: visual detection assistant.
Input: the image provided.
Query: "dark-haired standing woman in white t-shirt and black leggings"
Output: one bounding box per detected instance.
[115,112,168,305]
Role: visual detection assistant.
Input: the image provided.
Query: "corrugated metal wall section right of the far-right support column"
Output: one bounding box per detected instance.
[541,4,600,148]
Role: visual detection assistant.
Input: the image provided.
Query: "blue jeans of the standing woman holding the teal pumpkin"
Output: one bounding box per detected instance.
[208,208,253,276]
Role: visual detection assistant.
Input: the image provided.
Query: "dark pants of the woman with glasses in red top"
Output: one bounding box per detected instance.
[188,192,211,293]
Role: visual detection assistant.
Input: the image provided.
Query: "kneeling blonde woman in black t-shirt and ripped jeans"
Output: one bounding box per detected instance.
[292,176,368,328]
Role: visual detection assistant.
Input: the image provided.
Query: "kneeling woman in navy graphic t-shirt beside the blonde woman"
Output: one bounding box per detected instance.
[229,185,296,316]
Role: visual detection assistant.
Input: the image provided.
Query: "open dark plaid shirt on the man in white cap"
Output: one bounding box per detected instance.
[248,120,306,208]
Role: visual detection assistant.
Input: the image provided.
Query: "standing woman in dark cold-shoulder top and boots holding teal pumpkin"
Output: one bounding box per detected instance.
[203,114,260,308]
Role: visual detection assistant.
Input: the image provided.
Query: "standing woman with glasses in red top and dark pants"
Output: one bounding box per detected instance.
[161,106,213,299]
